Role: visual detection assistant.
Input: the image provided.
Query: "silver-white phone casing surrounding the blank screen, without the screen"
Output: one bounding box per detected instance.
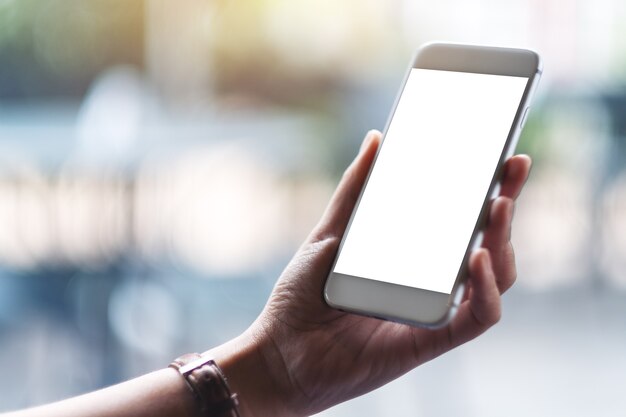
[324,42,542,328]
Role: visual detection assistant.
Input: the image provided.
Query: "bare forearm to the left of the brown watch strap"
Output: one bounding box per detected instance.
[2,368,196,417]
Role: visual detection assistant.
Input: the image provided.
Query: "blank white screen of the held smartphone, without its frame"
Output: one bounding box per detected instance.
[333,68,528,294]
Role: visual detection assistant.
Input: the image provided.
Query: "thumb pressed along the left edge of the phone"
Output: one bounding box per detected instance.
[311,130,381,240]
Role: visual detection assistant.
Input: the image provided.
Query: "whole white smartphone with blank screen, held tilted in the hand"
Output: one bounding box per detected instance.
[324,43,541,328]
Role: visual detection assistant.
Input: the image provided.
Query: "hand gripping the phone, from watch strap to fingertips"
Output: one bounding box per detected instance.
[211,128,530,416]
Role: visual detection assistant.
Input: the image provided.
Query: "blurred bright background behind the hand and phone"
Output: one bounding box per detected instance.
[0,0,626,416]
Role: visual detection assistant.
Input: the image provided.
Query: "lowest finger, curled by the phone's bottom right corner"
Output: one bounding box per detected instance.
[448,249,501,347]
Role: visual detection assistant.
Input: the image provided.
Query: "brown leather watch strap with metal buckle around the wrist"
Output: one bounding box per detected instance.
[169,353,239,417]
